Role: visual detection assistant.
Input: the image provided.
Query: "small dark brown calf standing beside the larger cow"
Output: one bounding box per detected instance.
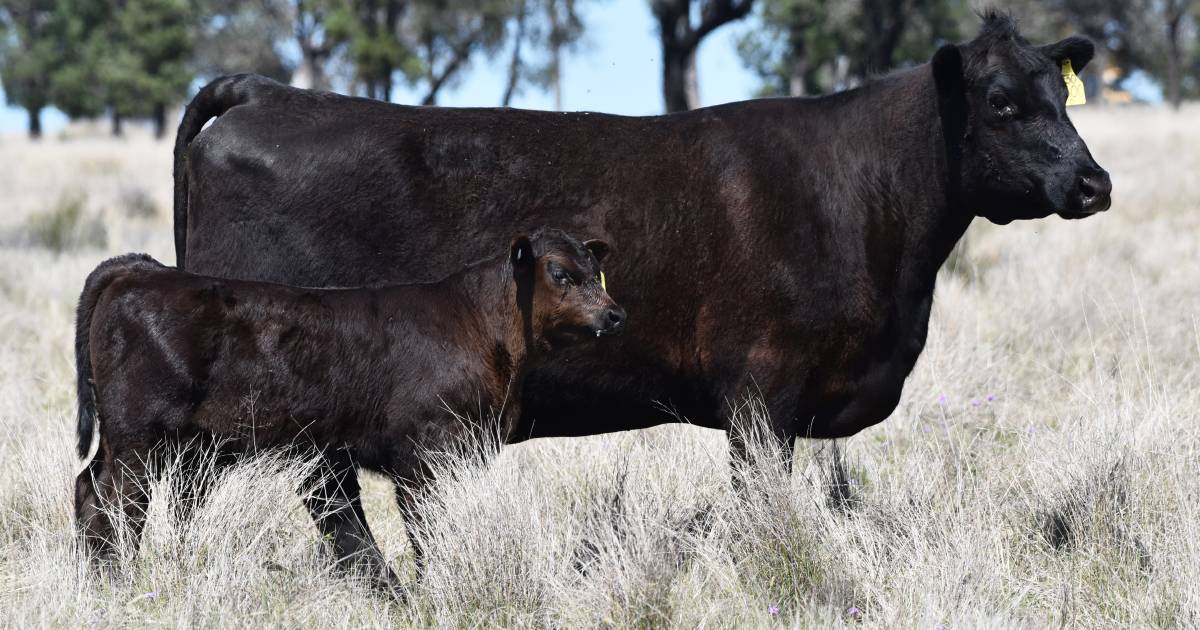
[76,230,625,583]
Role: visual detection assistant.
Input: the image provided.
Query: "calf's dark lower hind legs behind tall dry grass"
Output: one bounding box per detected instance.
[76,444,151,560]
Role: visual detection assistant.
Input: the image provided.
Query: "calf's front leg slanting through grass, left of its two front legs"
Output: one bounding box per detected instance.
[305,451,400,592]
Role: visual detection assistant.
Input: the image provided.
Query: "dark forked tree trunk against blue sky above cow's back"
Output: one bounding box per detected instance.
[650,0,755,112]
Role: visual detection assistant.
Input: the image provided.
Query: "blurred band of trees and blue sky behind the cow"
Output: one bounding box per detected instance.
[0,0,1200,137]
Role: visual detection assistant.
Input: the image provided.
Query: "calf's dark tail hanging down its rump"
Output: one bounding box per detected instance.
[76,253,164,458]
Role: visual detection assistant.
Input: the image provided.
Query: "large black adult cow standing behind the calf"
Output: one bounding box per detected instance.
[175,13,1111,463]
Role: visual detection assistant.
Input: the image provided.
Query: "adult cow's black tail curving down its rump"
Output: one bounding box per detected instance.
[175,74,275,269]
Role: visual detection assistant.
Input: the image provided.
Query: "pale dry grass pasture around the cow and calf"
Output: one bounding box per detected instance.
[0,106,1200,629]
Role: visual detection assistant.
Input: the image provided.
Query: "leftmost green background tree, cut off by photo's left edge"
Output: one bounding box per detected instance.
[0,0,59,138]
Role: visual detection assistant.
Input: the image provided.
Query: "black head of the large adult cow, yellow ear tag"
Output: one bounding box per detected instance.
[932,12,1112,223]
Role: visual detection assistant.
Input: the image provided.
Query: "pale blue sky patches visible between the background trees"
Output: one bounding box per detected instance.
[0,0,758,133]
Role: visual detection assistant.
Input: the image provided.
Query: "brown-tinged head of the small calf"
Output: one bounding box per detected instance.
[510,228,625,348]
